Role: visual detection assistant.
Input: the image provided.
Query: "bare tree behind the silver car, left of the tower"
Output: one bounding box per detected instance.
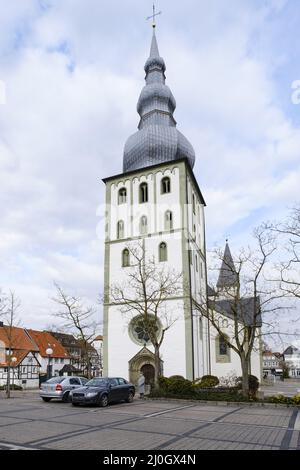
[52,283,97,378]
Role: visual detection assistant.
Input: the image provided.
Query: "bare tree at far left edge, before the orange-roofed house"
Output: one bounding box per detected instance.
[0,291,21,398]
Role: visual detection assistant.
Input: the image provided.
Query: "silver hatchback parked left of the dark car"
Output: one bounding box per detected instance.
[40,376,88,402]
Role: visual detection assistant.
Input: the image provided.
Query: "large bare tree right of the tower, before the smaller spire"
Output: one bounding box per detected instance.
[195,227,284,397]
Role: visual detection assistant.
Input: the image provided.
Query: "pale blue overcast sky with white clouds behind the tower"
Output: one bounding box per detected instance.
[0,0,300,338]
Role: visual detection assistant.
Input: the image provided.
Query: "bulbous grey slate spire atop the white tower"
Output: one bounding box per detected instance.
[123,28,195,172]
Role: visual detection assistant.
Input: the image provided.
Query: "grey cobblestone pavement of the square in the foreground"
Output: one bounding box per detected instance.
[0,394,300,450]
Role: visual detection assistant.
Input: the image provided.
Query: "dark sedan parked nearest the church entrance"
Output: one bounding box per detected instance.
[70,377,135,407]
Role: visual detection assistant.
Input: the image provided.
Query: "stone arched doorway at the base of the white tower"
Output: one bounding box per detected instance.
[128,347,163,387]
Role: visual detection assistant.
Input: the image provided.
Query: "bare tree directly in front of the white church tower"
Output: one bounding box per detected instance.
[105,242,183,386]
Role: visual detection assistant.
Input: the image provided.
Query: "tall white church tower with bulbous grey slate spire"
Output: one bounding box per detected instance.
[103,27,209,383]
